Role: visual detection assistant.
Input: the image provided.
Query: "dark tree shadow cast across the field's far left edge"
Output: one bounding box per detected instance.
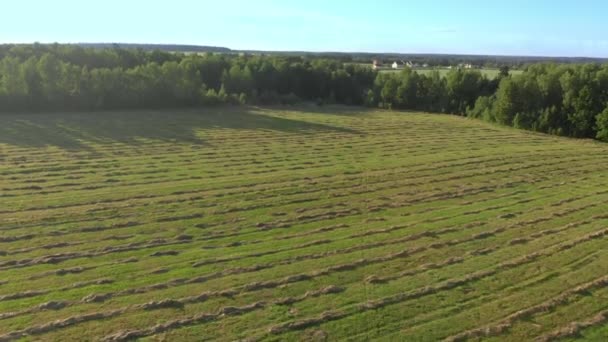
[0,107,357,149]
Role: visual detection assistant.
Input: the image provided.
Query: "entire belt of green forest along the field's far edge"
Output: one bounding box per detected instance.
[0,44,608,140]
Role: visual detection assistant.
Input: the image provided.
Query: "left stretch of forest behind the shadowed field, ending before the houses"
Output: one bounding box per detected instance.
[0,45,375,111]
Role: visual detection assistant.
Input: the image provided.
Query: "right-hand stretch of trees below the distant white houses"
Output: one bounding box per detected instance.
[367,64,608,141]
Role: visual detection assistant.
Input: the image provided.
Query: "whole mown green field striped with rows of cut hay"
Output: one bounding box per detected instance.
[0,107,608,341]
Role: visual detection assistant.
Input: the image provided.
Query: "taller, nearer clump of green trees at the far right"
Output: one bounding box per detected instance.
[467,64,608,140]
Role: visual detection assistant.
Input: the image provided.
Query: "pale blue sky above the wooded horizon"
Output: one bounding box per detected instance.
[0,0,608,57]
